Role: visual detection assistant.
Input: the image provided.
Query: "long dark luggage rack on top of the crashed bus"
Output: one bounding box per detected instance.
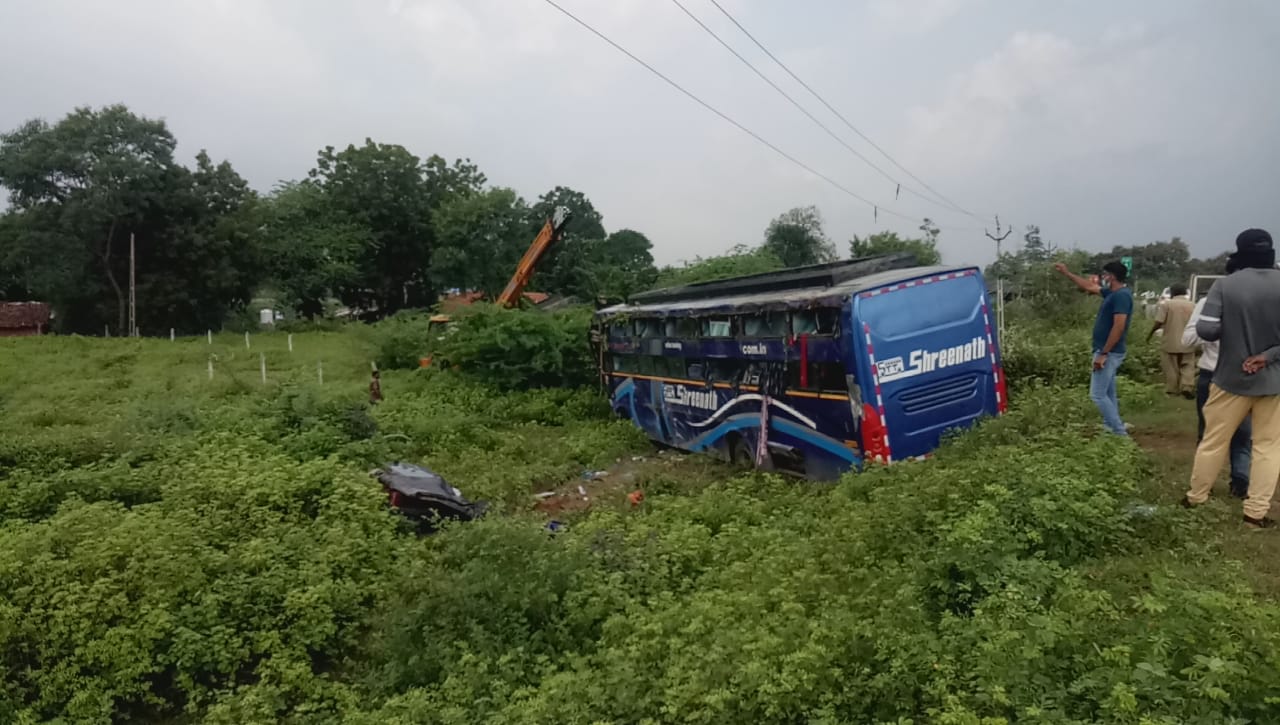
[631,252,918,305]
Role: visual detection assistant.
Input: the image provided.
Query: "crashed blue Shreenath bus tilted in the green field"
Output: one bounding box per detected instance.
[593,255,1007,480]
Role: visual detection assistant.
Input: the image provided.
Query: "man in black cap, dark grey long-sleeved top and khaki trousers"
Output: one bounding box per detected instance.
[1183,229,1280,529]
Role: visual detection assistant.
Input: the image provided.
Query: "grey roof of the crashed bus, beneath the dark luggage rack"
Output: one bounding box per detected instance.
[595,261,973,316]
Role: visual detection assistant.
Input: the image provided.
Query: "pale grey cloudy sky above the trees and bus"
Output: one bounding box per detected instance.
[0,0,1280,263]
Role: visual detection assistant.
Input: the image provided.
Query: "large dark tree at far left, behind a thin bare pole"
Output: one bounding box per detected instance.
[0,105,257,333]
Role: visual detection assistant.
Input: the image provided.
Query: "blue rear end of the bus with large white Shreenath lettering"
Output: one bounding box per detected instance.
[854,270,1004,460]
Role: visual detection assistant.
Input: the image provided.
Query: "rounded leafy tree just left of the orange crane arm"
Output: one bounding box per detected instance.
[431,188,532,297]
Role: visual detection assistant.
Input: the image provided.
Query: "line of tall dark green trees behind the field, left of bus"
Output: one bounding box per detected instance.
[0,105,658,334]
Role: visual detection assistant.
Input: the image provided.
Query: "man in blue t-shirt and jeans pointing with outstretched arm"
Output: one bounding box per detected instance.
[1053,261,1133,436]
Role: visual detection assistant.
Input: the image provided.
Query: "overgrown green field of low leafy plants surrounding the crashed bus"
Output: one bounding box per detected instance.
[0,327,1280,725]
